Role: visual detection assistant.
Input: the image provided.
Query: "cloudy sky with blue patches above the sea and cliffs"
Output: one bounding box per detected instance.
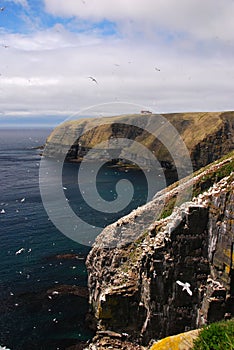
[0,0,234,127]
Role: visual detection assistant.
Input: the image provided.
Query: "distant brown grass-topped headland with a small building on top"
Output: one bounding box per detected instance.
[44,112,234,170]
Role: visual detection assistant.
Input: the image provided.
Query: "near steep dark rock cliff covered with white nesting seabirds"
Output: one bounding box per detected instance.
[87,154,234,344]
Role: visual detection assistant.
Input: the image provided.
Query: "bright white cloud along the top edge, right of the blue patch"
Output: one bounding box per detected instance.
[45,0,234,40]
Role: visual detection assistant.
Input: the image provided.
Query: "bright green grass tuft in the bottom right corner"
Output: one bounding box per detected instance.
[192,319,234,350]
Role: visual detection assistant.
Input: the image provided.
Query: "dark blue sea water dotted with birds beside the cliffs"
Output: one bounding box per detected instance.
[0,129,165,350]
